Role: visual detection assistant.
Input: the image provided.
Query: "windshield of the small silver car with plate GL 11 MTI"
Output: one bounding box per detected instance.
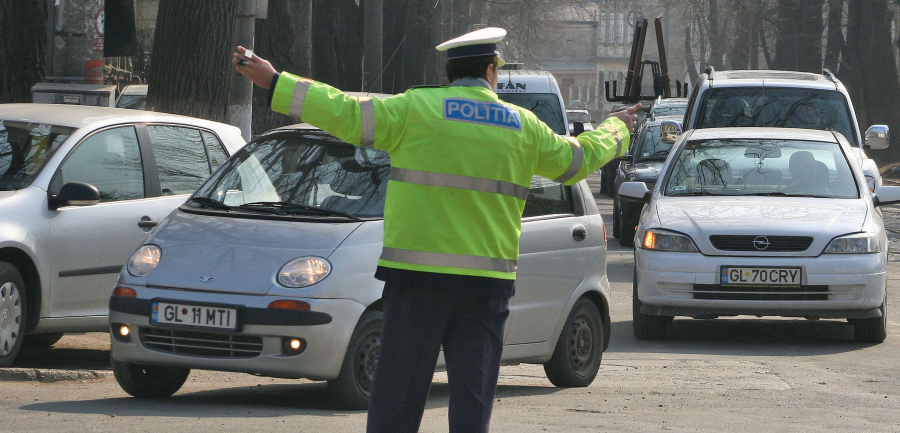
[188,131,390,218]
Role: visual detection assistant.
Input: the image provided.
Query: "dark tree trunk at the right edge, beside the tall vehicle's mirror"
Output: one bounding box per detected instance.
[840,0,900,163]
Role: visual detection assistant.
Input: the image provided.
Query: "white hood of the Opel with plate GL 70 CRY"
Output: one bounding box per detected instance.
[656,197,868,255]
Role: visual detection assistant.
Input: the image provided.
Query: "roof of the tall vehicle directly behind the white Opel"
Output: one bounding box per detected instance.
[709,70,837,90]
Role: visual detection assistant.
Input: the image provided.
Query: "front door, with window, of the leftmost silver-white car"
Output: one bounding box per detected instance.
[45,125,156,317]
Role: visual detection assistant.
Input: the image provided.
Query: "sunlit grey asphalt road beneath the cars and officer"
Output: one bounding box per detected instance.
[0,174,900,433]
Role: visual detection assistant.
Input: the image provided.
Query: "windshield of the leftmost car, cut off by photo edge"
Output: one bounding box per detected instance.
[0,120,75,191]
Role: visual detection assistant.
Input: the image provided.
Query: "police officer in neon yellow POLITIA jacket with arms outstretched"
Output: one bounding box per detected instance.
[232,28,640,433]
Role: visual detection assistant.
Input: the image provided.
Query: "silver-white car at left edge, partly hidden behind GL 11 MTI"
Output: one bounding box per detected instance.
[0,104,244,367]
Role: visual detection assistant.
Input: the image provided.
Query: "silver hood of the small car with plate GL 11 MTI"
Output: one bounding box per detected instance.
[146,210,363,295]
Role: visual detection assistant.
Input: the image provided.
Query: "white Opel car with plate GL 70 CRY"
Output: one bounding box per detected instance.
[619,128,900,342]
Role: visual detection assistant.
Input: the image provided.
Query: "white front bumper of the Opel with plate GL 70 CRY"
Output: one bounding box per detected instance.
[635,247,886,318]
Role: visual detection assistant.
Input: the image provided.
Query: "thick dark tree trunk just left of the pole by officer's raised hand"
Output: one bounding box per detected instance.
[147,0,236,122]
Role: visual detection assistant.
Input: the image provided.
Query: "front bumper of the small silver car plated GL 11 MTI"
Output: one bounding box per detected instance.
[109,287,365,380]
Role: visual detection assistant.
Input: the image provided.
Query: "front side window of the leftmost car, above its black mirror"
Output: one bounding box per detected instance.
[54,126,144,202]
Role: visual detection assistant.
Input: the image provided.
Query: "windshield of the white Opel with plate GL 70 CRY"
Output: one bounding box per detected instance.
[665,139,859,198]
